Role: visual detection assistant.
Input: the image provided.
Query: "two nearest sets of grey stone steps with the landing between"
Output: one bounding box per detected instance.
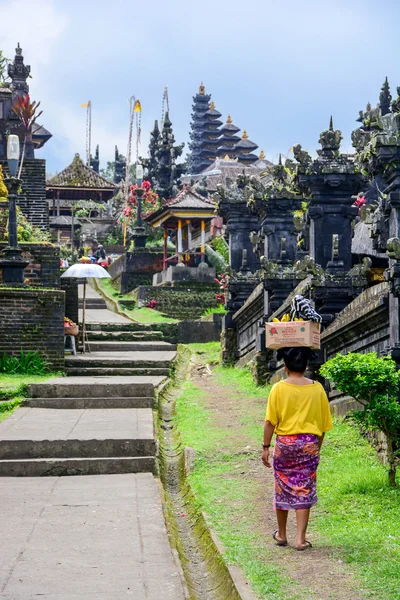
[0,376,165,477]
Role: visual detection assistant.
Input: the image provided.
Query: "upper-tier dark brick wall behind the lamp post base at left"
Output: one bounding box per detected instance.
[0,243,60,288]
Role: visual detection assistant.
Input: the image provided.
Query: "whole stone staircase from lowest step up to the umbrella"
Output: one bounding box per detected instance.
[0,290,177,476]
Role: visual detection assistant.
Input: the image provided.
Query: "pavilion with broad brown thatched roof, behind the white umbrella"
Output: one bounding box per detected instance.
[46,154,116,242]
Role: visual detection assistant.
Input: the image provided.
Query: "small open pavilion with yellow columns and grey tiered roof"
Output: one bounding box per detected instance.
[144,186,216,270]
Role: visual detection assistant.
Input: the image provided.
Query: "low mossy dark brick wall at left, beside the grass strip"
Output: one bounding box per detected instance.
[0,288,65,370]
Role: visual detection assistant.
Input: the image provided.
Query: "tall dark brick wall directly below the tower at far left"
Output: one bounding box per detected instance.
[0,158,49,230]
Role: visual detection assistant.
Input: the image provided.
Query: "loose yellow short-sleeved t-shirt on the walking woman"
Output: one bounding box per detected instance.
[265,380,332,436]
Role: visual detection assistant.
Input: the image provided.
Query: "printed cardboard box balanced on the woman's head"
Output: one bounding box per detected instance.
[265,321,321,350]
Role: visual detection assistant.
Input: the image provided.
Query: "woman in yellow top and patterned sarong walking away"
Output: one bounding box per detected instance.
[262,348,332,550]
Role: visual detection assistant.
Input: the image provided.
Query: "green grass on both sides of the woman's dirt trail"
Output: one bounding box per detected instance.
[176,343,400,600]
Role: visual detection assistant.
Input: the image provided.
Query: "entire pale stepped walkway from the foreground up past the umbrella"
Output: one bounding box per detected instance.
[0,287,185,600]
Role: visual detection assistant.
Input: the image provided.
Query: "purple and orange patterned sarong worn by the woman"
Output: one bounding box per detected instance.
[274,433,319,510]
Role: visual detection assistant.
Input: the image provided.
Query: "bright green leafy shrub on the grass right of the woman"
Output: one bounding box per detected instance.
[320,352,400,487]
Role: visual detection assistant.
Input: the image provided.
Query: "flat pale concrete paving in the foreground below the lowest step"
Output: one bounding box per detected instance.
[0,473,185,600]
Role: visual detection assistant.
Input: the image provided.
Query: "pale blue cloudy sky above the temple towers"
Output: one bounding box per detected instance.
[0,0,400,173]
